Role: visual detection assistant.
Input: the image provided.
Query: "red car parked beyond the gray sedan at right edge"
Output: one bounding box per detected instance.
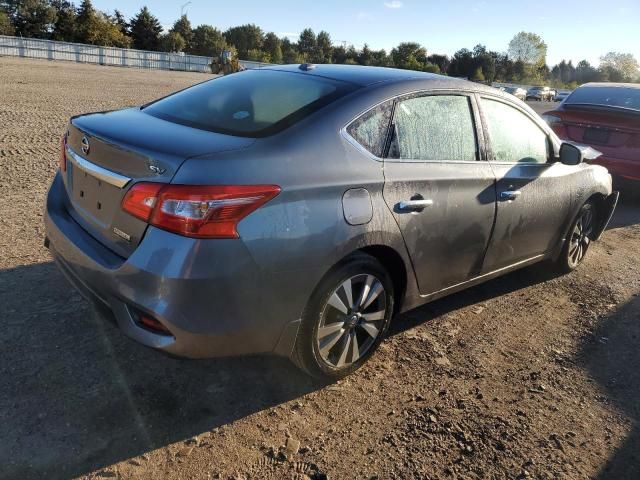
[542,83,640,182]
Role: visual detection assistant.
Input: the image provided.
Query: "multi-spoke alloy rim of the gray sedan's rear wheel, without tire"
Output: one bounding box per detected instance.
[316,274,387,368]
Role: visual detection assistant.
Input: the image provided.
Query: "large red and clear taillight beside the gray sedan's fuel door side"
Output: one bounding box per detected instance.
[122,183,280,238]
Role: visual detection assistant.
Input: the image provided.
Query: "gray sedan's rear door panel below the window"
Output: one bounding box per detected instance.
[384,161,495,295]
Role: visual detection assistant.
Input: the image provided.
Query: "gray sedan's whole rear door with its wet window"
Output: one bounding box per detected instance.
[384,92,495,295]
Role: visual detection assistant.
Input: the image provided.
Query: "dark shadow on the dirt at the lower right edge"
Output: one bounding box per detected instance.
[579,296,640,480]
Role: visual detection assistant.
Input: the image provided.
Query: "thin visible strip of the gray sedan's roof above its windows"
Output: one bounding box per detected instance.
[261,64,489,90]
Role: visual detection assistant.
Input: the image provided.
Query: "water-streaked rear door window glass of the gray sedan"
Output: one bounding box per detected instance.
[389,95,477,162]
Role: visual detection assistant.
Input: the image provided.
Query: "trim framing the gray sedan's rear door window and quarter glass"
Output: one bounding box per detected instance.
[340,88,488,164]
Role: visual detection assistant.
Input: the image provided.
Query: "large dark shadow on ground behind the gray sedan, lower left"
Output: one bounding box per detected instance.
[0,263,320,479]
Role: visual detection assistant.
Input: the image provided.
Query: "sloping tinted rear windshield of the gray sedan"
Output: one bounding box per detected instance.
[144,70,357,137]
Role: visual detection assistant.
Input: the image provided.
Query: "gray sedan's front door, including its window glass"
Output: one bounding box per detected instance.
[479,96,577,273]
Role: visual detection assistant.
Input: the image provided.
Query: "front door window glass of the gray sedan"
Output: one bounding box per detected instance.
[481,98,549,163]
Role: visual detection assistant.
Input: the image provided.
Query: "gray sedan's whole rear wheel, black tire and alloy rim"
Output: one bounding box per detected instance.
[292,253,394,380]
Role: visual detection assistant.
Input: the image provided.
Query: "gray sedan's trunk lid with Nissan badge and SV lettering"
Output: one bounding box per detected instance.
[63,108,254,258]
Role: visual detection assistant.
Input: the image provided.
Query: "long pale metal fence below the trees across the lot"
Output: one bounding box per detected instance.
[0,35,268,73]
